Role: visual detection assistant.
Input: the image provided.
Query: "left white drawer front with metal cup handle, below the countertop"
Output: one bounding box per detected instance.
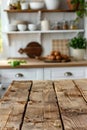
[1,68,43,87]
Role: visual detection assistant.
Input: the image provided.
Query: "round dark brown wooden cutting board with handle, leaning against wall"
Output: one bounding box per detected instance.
[18,41,42,58]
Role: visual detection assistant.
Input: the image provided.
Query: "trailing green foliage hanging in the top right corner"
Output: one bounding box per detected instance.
[67,0,87,19]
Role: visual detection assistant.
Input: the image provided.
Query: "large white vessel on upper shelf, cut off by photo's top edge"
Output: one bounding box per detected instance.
[45,0,59,10]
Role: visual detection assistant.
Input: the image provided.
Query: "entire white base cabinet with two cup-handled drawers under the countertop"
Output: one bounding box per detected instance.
[0,67,87,87]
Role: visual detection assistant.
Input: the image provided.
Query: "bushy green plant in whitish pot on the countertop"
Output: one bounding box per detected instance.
[69,35,87,60]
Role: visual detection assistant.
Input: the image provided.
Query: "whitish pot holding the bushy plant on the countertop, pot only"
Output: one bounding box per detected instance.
[70,47,85,60]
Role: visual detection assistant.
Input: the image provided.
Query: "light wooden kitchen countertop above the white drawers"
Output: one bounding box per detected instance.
[0,58,87,69]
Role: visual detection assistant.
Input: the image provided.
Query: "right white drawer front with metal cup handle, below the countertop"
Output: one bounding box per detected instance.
[44,67,85,80]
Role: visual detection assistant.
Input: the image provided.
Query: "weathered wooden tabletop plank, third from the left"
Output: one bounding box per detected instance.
[54,80,87,130]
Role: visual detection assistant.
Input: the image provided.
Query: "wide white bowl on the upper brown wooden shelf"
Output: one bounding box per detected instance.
[30,1,44,9]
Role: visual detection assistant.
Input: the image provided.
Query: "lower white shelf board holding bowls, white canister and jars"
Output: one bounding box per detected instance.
[3,29,84,34]
